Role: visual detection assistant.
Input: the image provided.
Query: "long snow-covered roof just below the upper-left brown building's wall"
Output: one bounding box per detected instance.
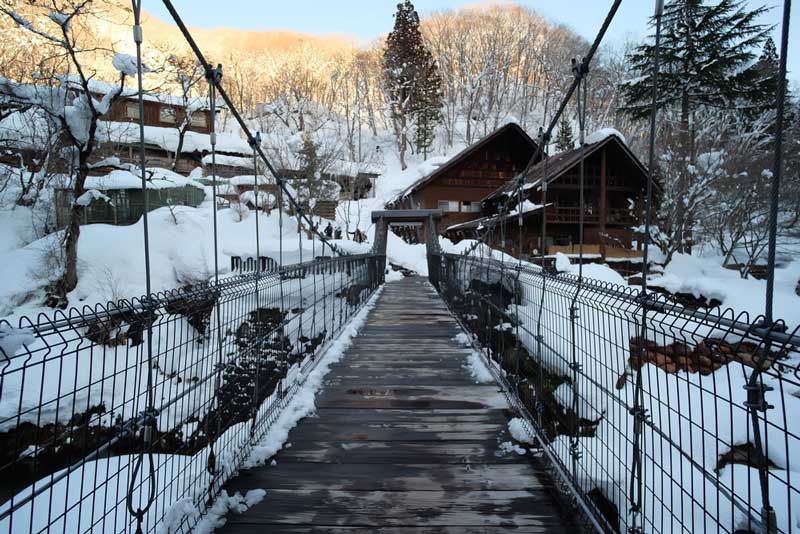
[97,121,252,159]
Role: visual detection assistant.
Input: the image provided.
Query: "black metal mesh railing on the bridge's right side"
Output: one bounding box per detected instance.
[430,254,800,533]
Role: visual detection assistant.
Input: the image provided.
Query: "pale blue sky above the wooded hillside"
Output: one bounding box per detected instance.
[143,0,800,81]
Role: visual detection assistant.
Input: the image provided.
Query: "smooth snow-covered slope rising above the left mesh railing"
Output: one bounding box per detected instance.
[0,195,318,322]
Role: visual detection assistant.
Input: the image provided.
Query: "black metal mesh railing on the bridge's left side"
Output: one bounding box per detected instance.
[0,255,383,533]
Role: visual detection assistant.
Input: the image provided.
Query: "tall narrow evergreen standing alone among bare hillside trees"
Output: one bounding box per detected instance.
[383,0,442,169]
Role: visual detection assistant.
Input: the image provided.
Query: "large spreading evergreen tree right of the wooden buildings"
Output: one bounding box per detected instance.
[622,0,769,257]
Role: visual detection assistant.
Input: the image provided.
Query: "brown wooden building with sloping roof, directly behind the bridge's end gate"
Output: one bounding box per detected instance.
[387,123,537,240]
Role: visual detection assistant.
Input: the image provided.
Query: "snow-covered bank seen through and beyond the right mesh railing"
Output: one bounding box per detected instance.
[509,261,800,532]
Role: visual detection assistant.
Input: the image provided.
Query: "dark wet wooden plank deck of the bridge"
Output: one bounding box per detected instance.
[218,277,576,534]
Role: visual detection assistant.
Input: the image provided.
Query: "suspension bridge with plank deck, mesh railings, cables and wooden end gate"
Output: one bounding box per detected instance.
[0,0,800,533]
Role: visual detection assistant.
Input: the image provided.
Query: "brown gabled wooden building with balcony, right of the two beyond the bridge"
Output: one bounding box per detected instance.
[446,131,648,260]
